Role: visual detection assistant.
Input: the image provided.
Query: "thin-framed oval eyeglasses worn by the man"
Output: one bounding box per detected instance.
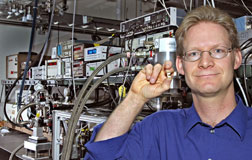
[183,46,233,62]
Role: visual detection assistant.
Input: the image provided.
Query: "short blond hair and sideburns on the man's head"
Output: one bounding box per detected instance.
[175,6,239,57]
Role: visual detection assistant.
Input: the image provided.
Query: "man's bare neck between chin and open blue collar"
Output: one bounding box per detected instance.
[193,86,236,127]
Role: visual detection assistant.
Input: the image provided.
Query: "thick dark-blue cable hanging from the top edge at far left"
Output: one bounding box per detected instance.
[17,0,38,110]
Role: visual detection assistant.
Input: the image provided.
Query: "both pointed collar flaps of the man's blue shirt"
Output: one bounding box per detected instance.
[185,95,248,140]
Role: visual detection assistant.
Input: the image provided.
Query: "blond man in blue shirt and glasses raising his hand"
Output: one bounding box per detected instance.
[86,7,252,160]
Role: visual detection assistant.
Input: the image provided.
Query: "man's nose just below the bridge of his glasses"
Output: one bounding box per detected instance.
[198,51,214,69]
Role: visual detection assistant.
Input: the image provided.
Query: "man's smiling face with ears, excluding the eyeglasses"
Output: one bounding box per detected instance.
[176,22,241,96]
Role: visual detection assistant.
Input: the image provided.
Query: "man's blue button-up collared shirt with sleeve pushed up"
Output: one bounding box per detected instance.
[84,96,252,160]
